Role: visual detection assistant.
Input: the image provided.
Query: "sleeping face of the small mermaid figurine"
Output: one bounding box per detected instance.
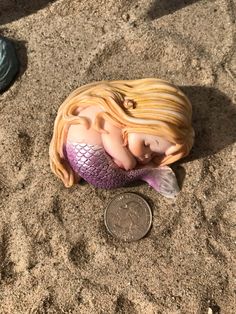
[128,133,173,164]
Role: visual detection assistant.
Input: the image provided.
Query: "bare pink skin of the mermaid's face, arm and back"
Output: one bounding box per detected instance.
[67,106,175,170]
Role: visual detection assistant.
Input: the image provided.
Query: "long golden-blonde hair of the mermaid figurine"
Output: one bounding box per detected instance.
[49,78,194,187]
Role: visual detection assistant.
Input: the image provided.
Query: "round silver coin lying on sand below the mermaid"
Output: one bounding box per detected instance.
[104,193,152,242]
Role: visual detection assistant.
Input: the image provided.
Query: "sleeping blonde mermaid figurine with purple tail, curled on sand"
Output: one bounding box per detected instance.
[49,78,194,198]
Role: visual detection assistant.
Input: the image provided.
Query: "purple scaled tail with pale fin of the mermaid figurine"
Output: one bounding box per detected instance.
[65,142,179,198]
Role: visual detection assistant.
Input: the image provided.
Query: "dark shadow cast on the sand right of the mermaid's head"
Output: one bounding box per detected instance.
[180,86,236,161]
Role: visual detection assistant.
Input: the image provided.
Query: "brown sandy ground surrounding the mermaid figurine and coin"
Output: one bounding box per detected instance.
[0,0,236,314]
